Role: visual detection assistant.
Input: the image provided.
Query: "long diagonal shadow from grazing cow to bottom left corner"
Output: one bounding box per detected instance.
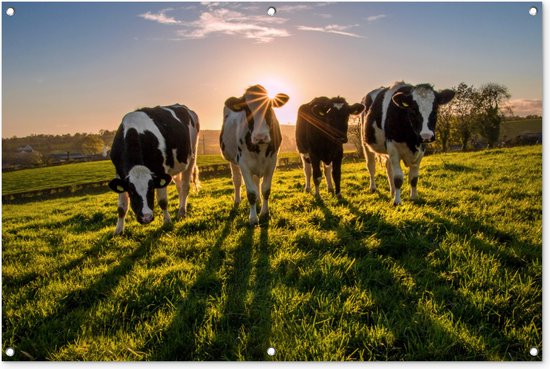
[7,229,163,360]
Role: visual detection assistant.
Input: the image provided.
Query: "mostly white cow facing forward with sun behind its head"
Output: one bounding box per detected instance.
[220,85,289,225]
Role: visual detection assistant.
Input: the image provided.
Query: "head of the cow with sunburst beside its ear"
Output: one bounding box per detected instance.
[225,85,289,145]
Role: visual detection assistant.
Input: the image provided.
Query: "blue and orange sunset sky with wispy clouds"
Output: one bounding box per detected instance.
[2,2,543,137]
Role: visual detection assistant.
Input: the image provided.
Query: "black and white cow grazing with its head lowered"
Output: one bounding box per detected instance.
[109,104,199,234]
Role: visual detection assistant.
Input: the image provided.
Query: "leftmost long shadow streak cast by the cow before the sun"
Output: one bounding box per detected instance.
[150,207,238,361]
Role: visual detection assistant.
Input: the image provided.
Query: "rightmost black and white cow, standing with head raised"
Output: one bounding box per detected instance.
[361,82,455,205]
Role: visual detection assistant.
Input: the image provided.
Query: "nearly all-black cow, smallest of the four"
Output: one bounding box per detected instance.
[296,97,365,197]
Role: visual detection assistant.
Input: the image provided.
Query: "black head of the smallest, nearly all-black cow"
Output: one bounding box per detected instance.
[311,97,365,144]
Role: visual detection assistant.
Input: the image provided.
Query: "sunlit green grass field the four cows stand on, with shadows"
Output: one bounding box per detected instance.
[2,145,542,361]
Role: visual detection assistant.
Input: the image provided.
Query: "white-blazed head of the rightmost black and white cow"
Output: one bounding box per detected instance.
[392,84,455,142]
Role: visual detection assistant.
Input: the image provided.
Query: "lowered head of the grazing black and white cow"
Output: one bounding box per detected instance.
[109,165,172,224]
